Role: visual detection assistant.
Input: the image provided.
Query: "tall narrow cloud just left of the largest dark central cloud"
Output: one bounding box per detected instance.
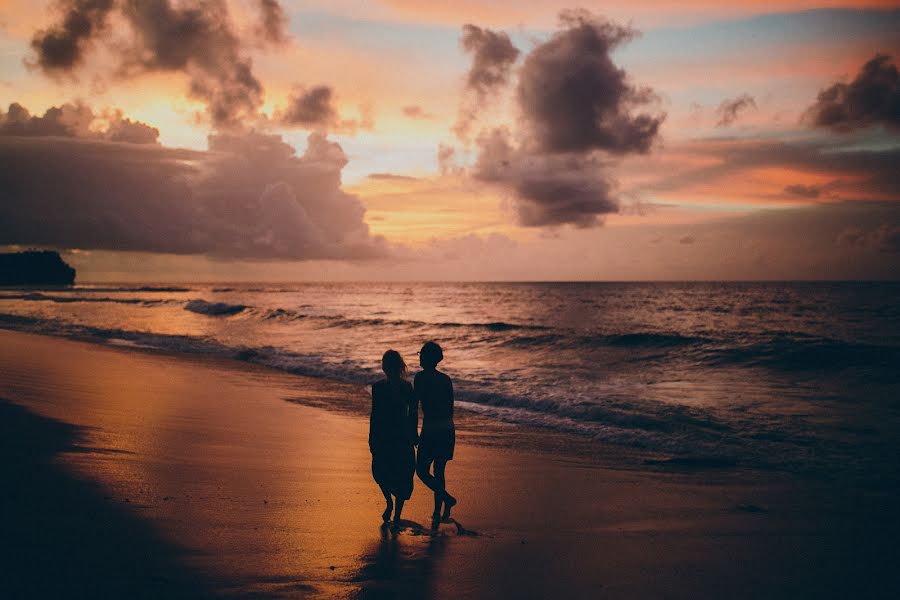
[453,24,519,141]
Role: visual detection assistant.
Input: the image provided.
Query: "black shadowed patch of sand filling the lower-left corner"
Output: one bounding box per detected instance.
[0,400,222,599]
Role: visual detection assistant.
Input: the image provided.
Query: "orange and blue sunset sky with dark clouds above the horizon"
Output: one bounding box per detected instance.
[0,0,900,281]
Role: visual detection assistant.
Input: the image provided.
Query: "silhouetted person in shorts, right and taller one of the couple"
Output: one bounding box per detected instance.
[412,342,456,528]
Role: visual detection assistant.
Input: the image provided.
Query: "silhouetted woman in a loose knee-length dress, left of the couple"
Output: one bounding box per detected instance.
[369,350,418,528]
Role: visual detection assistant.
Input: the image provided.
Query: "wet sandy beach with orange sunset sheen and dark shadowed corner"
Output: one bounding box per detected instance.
[0,331,900,598]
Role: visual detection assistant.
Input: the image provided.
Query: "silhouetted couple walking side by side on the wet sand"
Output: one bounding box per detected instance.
[369,342,456,530]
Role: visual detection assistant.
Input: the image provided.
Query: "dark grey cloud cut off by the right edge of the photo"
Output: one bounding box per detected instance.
[805,54,900,132]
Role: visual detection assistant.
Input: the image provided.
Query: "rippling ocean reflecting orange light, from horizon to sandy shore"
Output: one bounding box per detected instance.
[0,283,900,481]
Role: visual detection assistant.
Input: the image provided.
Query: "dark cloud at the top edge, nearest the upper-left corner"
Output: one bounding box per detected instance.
[31,0,114,72]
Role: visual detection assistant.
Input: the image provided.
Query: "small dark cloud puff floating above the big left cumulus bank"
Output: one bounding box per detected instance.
[275,85,374,134]
